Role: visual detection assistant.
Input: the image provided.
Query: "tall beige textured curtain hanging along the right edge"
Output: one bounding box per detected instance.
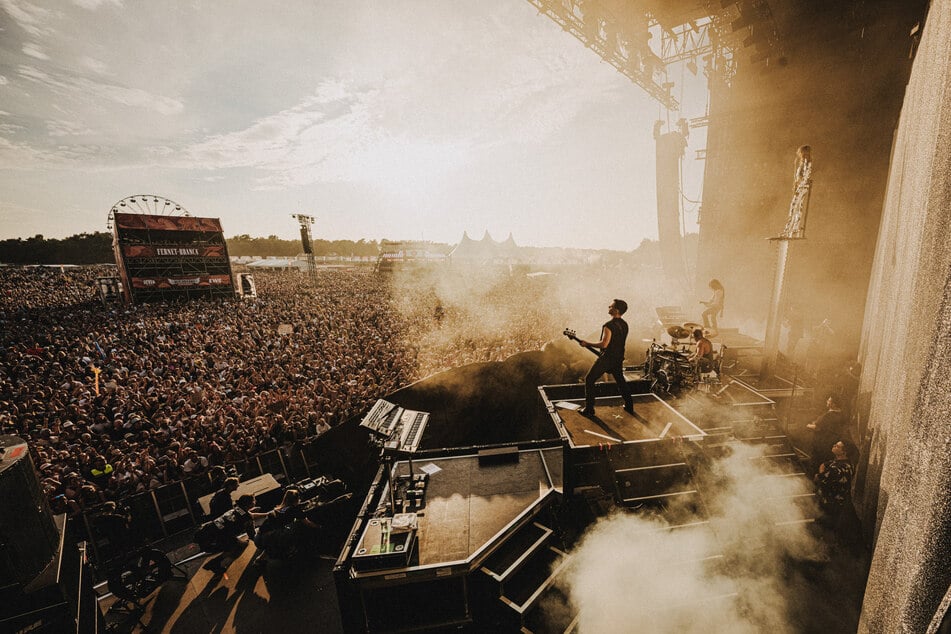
[855,0,951,633]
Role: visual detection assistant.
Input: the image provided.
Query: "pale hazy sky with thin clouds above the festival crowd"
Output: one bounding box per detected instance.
[0,0,706,250]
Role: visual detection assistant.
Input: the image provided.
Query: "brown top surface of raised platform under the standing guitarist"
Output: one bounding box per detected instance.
[553,394,705,447]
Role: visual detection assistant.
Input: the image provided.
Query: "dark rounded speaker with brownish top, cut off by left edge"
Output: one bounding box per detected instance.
[0,436,59,585]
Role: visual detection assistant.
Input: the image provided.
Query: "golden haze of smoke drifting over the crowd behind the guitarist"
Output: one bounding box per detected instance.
[392,256,699,377]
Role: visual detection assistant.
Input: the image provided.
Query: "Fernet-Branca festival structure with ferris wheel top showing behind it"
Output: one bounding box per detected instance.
[109,194,234,303]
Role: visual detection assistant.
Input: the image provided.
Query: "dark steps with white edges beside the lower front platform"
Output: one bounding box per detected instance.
[477,521,576,634]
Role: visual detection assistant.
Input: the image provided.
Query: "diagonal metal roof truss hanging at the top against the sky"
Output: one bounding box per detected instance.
[528,0,680,110]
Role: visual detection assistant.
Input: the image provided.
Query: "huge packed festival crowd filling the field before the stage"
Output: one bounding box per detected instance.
[0,267,668,514]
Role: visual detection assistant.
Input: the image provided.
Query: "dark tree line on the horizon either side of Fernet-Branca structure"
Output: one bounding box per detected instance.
[0,231,380,264]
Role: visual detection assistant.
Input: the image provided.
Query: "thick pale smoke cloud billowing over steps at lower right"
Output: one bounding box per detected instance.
[561,445,823,634]
